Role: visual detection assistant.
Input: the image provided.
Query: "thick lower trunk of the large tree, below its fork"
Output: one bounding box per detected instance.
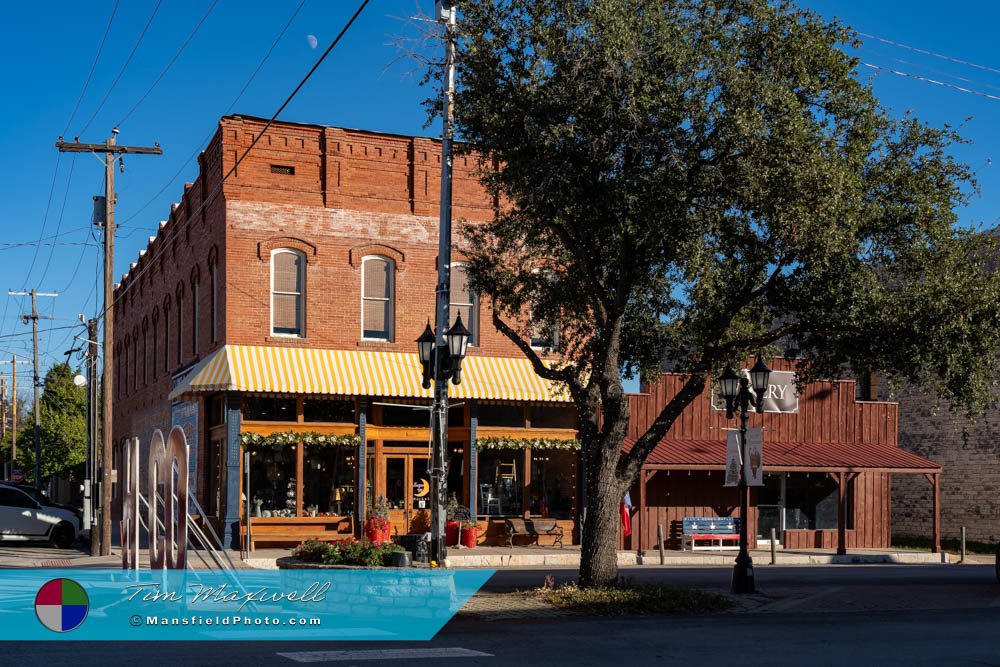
[580,454,625,588]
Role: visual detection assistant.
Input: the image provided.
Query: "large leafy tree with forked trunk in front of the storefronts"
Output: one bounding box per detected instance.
[440,0,1000,581]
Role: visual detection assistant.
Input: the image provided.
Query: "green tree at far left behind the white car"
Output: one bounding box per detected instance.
[13,363,87,481]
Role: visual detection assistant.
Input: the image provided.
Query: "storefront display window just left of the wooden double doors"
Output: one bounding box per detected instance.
[302,447,356,516]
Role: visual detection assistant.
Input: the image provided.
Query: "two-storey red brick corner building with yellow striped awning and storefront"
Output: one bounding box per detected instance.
[114,116,577,544]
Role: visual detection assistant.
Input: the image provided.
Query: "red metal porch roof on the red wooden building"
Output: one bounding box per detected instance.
[625,438,942,473]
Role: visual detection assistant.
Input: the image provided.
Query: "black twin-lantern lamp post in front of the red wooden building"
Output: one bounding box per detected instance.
[719,354,771,593]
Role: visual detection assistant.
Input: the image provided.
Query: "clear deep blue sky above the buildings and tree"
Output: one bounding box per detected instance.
[0,0,1000,394]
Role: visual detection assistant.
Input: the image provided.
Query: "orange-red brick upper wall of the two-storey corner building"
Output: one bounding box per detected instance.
[114,116,536,440]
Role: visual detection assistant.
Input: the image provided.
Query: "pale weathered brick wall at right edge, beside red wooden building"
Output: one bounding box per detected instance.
[892,388,1000,542]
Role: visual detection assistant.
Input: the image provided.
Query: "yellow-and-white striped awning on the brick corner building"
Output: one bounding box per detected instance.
[170,345,570,403]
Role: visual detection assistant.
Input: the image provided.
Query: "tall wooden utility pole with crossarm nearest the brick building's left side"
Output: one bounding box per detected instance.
[56,128,163,556]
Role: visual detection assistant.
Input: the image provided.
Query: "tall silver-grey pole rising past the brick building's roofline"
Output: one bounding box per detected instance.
[430,0,457,563]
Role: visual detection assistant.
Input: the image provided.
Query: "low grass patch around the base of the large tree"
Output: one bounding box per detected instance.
[538,580,732,616]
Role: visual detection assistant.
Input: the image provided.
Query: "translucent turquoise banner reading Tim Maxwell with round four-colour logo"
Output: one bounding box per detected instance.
[0,569,494,641]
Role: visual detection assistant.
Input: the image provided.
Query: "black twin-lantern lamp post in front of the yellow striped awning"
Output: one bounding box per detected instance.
[417,315,472,562]
